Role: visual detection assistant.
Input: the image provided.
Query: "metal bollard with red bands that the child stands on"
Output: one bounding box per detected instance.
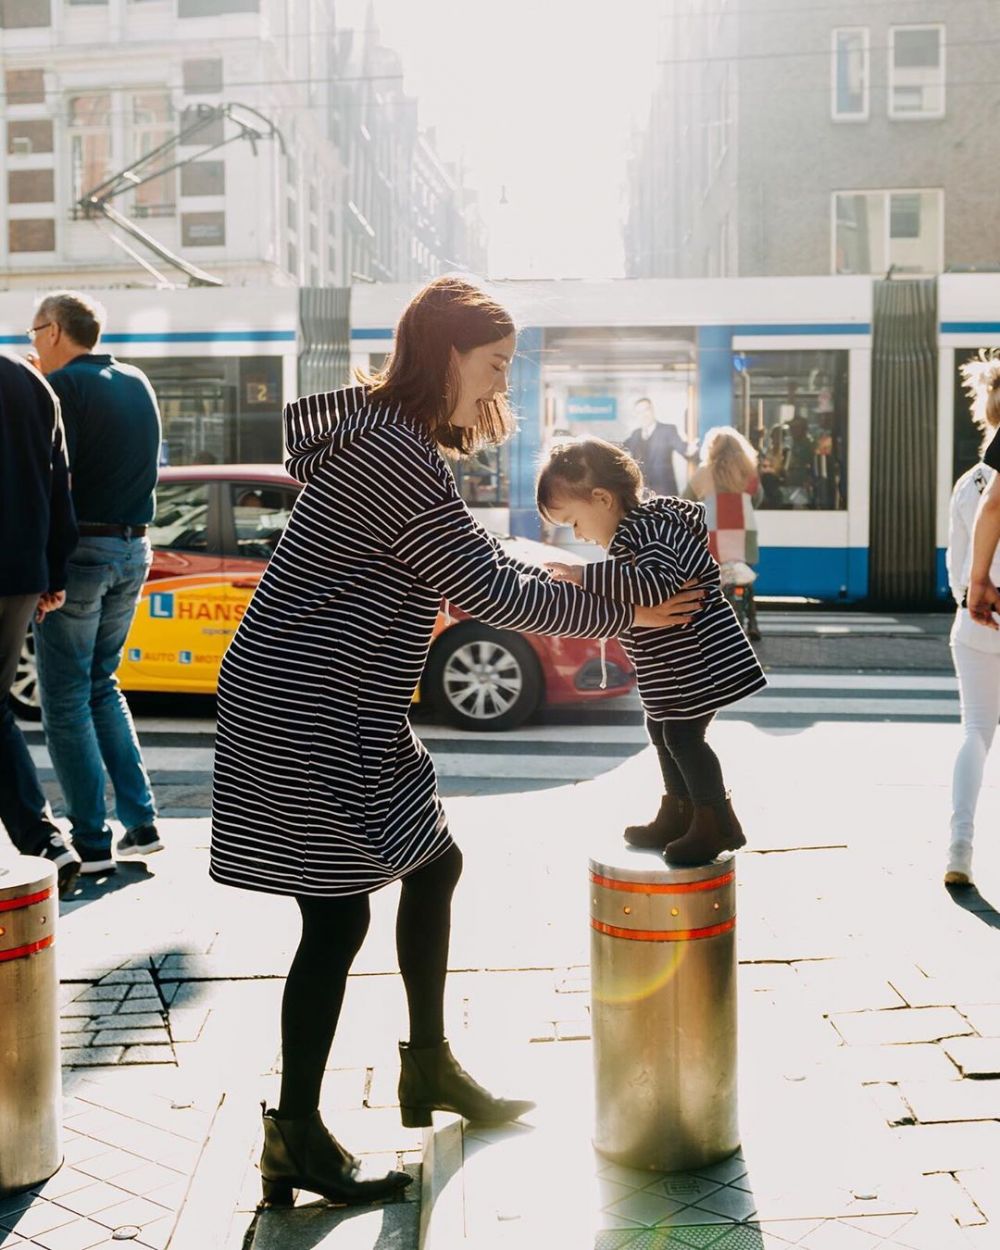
[590,846,740,1171]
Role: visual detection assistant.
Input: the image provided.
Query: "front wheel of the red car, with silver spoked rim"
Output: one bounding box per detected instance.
[423,621,544,730]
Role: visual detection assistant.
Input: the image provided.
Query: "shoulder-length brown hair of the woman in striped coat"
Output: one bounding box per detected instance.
[359,278,515,455]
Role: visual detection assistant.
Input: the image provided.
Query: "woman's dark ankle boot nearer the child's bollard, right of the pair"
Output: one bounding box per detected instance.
[399,1041,535,1129]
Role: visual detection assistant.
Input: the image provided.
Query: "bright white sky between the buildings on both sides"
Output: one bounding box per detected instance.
[338,0,660,278]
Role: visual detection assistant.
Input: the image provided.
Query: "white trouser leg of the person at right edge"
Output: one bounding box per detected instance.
[951,643,1000,843]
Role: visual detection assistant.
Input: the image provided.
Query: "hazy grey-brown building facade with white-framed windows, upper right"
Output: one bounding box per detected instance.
[625,0,1000,278]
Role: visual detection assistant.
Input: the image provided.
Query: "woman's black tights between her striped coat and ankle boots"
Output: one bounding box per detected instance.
[278,845,461,1116]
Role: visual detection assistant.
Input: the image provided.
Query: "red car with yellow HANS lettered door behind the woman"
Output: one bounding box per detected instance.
[11,465,635,730]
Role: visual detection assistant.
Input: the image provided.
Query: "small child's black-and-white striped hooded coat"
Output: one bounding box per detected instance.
[584,495,768,720]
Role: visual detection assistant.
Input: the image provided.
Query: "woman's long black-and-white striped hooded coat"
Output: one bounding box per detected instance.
[210,388,633,898]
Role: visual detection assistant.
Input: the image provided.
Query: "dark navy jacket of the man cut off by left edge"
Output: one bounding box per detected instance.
[0,353,76,595]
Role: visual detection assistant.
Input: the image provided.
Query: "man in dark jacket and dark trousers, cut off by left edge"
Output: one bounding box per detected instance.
[0,354,80,894]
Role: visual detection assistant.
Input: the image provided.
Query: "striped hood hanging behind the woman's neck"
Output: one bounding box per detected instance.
[285,386,428,483]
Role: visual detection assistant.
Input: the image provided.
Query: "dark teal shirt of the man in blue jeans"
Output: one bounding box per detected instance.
[49,353,160,525]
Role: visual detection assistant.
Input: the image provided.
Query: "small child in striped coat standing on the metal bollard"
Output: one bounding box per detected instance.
[538,439,766,865]
